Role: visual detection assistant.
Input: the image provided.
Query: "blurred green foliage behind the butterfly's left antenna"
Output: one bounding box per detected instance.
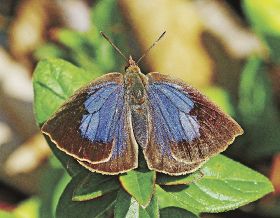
[34,0,127,76]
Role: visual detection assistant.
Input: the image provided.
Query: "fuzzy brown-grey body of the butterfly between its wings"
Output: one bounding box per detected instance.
[124,62,148,147]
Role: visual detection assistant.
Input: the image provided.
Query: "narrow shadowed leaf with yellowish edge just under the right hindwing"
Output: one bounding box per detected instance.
[156,170,203,185]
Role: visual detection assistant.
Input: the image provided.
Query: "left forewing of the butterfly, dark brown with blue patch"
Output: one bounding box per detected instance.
[42,73,137,167]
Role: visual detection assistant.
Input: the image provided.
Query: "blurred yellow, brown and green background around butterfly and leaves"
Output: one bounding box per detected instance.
[0,0,280,218]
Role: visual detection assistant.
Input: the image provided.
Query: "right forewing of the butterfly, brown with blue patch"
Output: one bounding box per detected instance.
[145,73,243,170]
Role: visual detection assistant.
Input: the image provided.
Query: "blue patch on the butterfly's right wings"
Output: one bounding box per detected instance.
[147,83,200,162]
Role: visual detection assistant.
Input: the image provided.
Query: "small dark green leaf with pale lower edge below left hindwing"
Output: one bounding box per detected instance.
[72,172,120,201]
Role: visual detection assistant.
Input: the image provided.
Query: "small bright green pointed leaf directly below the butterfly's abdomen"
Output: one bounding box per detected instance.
[119,168,156,207]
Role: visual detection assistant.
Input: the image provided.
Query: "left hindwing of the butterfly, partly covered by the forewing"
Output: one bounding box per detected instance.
[79,101,138,175]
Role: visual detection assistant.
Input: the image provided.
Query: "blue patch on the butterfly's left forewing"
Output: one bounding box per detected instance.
[79,83,124,143]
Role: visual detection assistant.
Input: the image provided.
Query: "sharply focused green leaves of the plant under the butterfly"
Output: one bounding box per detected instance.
[33,59,273,217]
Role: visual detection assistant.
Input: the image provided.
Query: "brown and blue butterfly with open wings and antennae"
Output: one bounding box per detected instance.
[41,32,243,175]
